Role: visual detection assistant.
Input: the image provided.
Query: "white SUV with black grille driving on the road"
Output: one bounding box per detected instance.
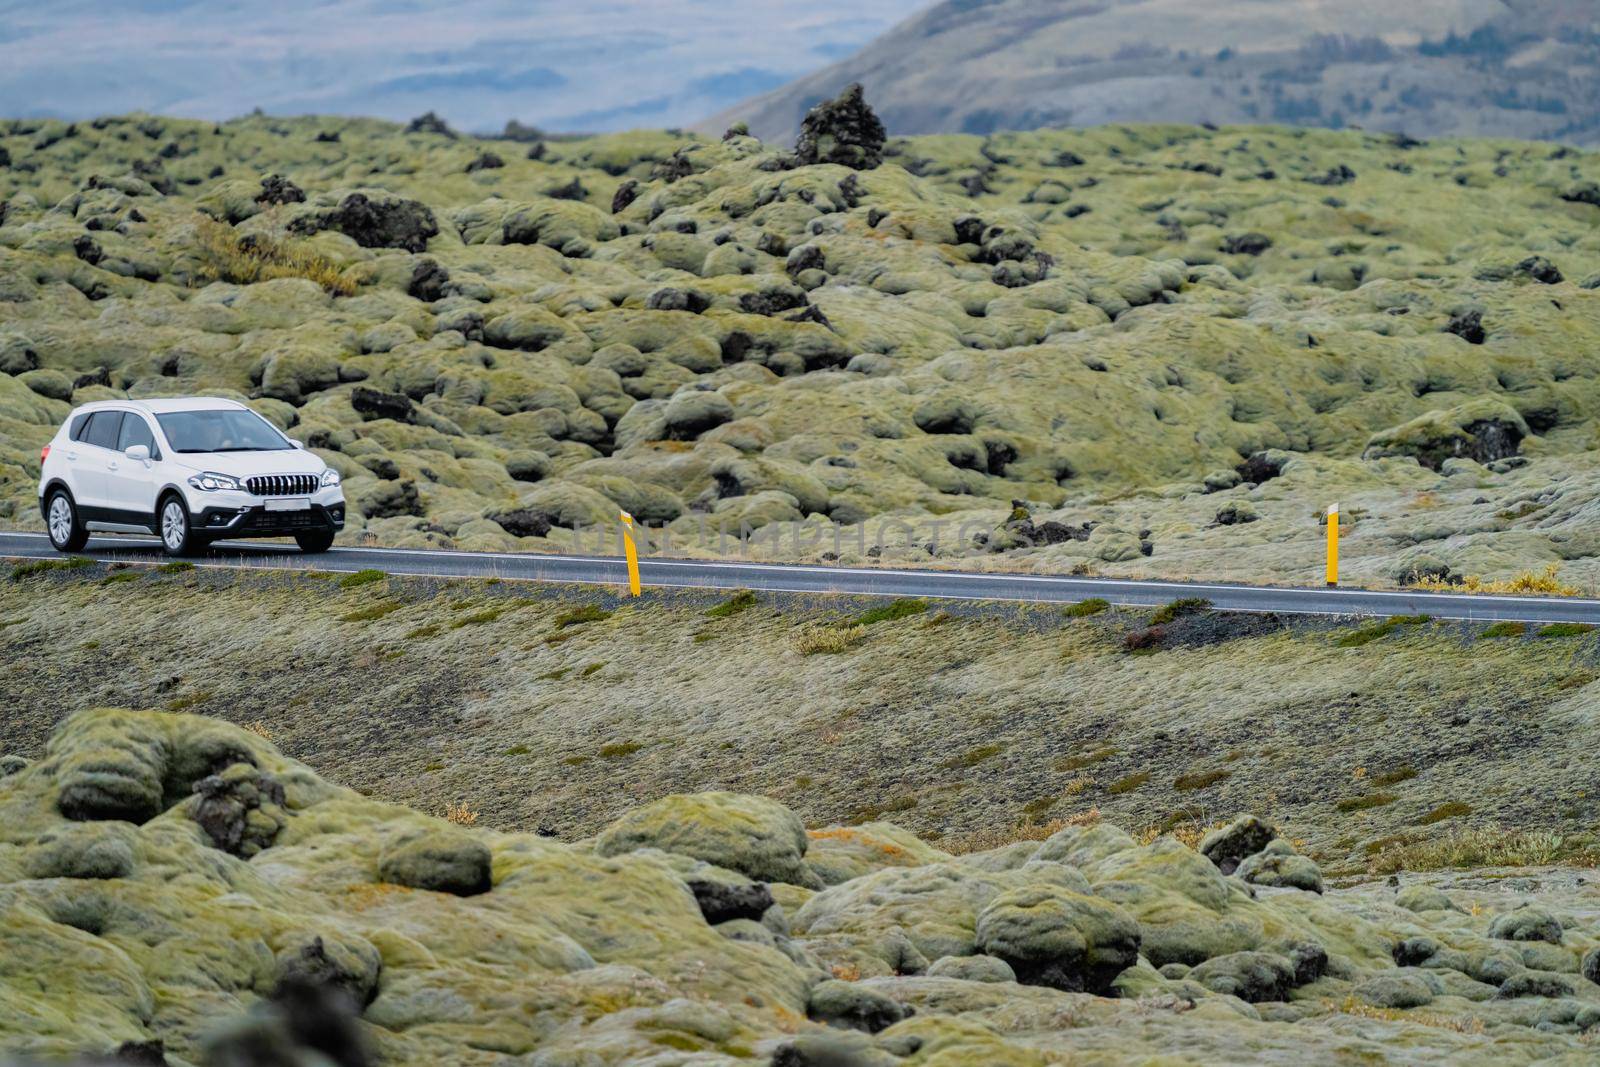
[38,397,344,555]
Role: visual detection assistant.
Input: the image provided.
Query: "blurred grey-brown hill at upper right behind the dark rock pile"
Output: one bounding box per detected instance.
[720,0,1600,144]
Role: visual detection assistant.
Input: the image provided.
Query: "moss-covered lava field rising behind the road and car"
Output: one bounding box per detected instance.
[0,109,1600,584]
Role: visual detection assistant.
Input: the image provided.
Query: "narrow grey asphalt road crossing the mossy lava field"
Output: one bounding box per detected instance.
[0,533,1600,624]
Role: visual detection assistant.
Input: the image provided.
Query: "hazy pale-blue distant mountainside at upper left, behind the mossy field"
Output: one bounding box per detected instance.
[0,0,926,131]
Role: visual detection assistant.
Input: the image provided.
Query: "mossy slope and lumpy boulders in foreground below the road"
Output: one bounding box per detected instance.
[9,579,1600,1067]
